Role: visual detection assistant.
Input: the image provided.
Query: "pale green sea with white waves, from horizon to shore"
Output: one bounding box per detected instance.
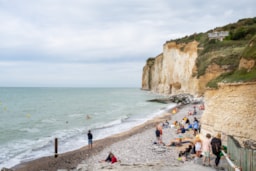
[0,88,174,168]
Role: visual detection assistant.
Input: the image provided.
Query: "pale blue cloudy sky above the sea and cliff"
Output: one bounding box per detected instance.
[0,0,256,88]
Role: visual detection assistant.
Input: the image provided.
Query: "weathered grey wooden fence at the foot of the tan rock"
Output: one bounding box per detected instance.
[227,136,256,171]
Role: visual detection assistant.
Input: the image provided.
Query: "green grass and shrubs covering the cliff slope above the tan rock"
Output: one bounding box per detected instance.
[174,17,256,88]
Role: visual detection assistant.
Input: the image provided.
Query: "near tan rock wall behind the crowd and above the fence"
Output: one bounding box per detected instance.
[201,82,256,144]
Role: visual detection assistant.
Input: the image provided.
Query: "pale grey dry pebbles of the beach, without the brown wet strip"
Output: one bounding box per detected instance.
[77,105,218,171]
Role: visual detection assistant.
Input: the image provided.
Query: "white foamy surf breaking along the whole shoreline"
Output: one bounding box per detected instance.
[0,104,175,168]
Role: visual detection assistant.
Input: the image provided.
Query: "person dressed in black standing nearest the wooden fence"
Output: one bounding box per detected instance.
[211,133,222,168]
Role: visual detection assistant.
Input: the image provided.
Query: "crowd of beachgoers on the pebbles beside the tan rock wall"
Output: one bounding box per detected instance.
[155,106,222,170]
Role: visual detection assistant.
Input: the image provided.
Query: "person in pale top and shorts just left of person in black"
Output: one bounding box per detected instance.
[202,133,211,166]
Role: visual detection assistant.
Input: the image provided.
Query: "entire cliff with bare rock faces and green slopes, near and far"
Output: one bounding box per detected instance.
[142,17,256,145]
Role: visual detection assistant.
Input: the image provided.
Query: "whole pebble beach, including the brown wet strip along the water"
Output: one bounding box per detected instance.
[10,104,227,171]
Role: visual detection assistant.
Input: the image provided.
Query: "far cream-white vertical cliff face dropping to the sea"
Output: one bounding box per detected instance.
[142,41,225,95]
